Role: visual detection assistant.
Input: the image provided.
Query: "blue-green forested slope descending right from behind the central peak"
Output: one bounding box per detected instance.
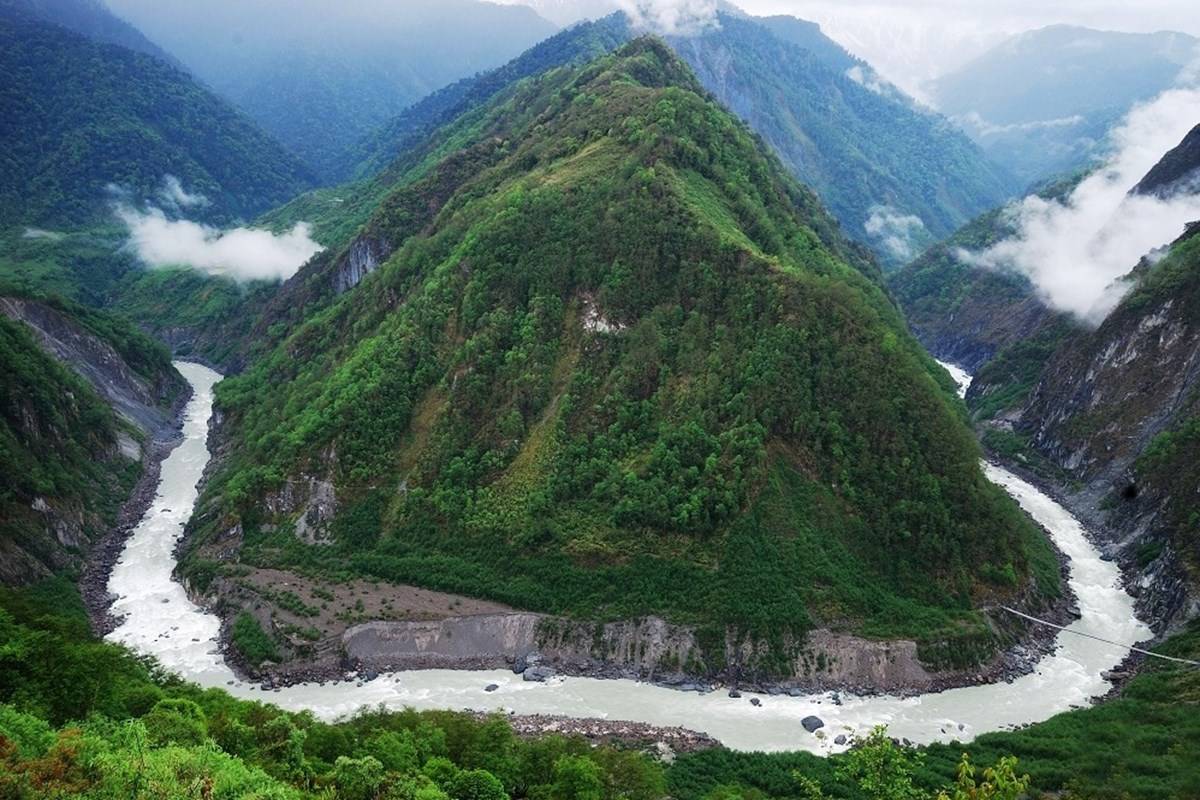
[672,14,1016,264]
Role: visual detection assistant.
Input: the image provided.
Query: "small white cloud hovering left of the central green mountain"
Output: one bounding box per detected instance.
[116,204,322,281]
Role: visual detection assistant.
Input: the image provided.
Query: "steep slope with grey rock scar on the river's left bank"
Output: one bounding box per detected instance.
[0,289,185,584]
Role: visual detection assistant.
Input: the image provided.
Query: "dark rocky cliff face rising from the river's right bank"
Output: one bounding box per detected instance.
[1016,227,1200,628]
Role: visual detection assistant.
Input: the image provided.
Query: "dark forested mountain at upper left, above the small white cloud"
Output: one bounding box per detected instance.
[0,6,311,228]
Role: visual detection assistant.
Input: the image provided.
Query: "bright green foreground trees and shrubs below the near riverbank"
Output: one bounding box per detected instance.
[0,578,1200,800]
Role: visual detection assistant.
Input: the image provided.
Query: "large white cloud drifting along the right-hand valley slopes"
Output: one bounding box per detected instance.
[959,89,1200,324]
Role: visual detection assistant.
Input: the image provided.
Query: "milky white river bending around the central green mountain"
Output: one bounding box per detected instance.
[109,362,1150,753]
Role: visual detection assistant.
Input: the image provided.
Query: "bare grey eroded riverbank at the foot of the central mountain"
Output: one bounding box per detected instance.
[340,604,1066,694]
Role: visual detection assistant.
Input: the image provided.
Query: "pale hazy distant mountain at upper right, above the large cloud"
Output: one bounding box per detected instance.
[931,25,1198,182]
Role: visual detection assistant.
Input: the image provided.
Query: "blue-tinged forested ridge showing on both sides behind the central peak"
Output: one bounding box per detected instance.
[321,14,1016,264]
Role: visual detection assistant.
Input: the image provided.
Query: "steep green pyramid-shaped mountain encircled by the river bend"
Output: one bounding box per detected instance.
[182,40,1057,676]
